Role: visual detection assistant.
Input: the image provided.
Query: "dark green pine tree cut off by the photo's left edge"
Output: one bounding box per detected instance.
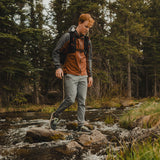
[0,0,31,106]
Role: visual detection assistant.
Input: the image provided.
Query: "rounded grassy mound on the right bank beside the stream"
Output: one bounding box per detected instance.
[119,100,160,128]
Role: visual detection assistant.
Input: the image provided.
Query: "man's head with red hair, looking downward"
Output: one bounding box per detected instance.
[77,14,94,35]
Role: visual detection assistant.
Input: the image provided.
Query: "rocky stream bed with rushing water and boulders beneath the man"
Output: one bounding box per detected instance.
[0,103,159,160]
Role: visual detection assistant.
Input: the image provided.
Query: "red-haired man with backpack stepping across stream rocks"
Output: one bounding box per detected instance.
[50,14,94,131]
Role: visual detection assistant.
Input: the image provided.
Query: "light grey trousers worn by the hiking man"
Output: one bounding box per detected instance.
[55,74,87,126]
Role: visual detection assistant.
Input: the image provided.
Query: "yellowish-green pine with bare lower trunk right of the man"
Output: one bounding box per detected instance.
[110,0,147,97]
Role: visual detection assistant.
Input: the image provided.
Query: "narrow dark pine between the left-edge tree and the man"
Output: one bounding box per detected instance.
[21,0,46,104]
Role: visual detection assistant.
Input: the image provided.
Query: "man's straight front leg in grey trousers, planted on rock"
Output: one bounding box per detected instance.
[77,76,87,127]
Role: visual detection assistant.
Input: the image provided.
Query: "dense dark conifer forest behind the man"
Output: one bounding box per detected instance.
[0,0,160,107]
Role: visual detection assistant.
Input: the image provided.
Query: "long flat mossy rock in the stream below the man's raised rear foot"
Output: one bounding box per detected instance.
[25,127,68,143]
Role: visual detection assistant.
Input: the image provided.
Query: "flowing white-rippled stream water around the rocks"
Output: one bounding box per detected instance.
[0,105,134,160]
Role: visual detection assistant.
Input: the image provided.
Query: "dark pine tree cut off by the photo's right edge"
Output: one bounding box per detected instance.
[144,0,160,96]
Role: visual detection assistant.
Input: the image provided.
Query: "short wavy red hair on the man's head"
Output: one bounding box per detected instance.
[78,13,94,27]
